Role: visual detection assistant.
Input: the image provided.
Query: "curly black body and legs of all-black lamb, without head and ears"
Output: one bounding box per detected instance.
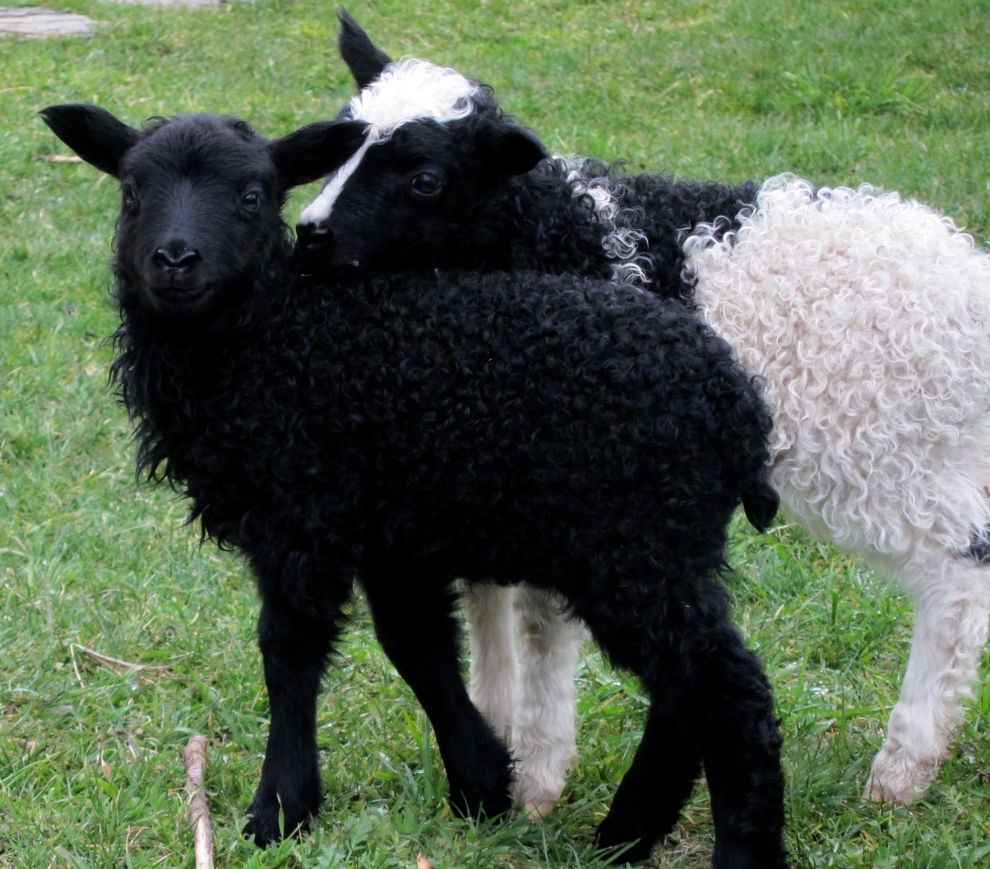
[114,264,782,860]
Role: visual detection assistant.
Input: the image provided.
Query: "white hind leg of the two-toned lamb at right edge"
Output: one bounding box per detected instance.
[864,556,990,803]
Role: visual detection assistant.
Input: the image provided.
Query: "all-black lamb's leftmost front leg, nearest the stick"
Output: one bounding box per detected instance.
[244,600,339,847]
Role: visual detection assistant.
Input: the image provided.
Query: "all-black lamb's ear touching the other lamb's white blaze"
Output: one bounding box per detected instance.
[269,121,368,189]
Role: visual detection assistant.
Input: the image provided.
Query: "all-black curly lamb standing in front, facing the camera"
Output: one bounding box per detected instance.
[42,98,786,867]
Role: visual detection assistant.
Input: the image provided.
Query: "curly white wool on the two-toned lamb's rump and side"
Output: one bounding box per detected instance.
[685,175,990,563]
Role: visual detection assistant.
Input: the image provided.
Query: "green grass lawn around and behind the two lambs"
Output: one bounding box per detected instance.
[0,0,990,869]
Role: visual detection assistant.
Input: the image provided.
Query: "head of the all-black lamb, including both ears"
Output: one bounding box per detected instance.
[42,106,364,319]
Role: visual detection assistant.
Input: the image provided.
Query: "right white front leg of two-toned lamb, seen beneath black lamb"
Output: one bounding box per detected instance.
[512,585,585,817]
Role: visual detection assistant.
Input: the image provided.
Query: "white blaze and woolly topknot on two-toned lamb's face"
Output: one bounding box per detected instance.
[299,57,479,223]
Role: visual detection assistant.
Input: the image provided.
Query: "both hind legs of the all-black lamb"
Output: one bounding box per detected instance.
[578,580,787,869]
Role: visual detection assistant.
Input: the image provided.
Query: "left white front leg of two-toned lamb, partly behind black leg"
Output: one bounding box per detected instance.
[461,583,519,745]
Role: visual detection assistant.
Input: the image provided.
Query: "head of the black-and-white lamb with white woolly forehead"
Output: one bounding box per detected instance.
[296,12,547,273]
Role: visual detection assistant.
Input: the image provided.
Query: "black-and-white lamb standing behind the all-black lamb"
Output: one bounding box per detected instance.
[298,14,990,814]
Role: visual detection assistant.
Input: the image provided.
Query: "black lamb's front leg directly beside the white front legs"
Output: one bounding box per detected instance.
[363,576,512,818]
